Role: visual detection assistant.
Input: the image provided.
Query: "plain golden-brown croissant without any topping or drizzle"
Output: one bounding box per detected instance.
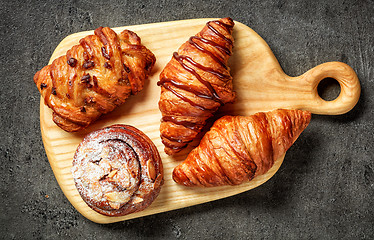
[173,110,311,187]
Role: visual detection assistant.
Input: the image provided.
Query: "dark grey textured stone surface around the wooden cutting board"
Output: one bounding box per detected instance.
[0,0,374,239]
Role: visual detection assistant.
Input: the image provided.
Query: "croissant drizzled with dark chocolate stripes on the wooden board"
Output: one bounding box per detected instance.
[158,18,235,155]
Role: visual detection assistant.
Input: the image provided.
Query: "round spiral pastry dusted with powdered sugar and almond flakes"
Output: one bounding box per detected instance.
[71,125,164,216]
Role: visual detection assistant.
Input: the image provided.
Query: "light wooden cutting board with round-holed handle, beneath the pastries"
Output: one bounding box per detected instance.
[40,19,360,223]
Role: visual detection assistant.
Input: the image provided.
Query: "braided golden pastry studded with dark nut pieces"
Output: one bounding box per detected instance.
[34,27,156,132]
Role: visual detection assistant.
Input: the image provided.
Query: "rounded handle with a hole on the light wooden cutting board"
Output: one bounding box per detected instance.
[292,62,361,115]
